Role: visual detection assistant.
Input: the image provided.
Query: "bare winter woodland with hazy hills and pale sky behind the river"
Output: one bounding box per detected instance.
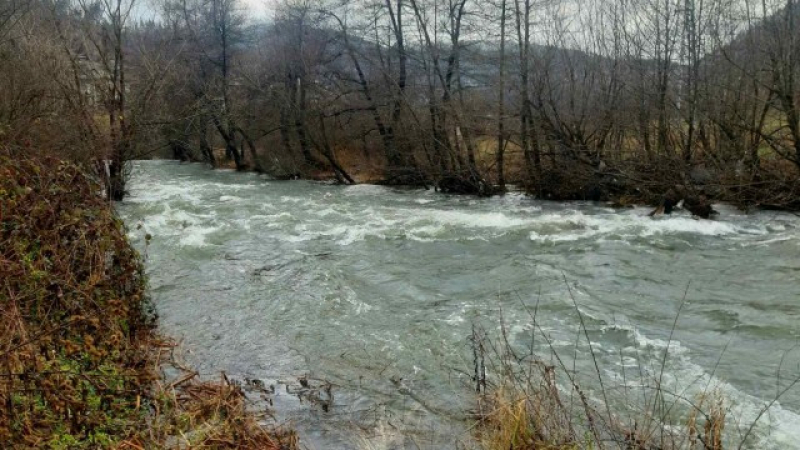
[0,0,800,208]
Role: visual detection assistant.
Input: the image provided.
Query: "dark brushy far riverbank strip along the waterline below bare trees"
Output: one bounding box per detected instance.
[197,151,800,219]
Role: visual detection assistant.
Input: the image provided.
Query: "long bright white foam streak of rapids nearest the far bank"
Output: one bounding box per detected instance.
[266,198,780,245]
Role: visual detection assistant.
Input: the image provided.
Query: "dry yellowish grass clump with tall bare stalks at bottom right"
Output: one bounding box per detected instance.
[471,288,736,450]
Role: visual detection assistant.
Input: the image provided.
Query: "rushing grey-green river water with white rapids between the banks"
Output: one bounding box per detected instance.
[119,162,800,449]
